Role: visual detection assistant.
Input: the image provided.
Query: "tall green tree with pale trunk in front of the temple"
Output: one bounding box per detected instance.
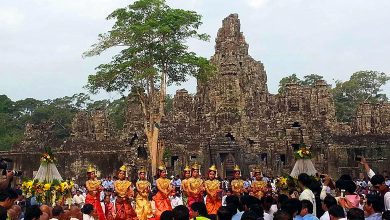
[84,0,214,173]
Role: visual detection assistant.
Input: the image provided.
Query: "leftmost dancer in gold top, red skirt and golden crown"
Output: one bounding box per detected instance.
[85,166,105,220]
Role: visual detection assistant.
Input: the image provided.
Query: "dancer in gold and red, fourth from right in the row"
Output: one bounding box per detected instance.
[188,163,204,210]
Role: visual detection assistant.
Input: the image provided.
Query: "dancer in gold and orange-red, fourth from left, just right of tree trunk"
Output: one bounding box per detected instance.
[153,165,173,220]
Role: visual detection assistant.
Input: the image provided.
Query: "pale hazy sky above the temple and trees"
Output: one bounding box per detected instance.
[0,0,390,101]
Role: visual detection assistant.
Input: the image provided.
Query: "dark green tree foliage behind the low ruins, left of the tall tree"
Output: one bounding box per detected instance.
[0,93,125,150]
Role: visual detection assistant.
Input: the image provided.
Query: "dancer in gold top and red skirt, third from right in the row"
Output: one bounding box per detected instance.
[204,165,222,215]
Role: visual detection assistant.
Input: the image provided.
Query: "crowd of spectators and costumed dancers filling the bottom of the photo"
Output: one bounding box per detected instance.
[0,158,390,220]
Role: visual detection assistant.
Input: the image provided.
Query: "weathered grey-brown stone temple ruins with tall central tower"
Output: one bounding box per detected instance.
[2,14,390,180]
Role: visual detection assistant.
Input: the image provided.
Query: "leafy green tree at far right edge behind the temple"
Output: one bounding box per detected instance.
[332,71,390,122]
